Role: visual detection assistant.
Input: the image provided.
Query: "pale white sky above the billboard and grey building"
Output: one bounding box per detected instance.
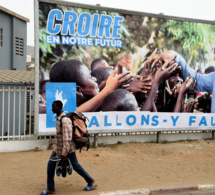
[0,0,215,46]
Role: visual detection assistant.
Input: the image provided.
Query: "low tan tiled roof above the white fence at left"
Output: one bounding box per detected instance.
[0,70,34,84]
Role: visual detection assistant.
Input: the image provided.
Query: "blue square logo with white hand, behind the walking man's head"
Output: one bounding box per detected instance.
[46,83,76,128]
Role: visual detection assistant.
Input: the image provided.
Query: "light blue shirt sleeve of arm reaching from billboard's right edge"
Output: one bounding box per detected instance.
[175,54,215,113]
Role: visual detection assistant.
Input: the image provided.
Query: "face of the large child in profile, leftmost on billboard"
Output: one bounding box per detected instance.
[79,66,99,98]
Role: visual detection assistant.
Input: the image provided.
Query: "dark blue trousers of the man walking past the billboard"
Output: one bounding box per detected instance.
[47,151,93,190]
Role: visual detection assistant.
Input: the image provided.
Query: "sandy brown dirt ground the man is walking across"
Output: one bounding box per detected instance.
[0,140,215,195]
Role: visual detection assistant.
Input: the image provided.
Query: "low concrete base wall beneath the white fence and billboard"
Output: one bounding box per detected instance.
[0,132,212,152]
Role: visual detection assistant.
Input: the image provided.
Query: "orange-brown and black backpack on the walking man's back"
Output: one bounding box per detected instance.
[60,111,90,152]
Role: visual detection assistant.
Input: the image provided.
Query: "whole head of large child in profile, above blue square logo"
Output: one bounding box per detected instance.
[49,59,99,98]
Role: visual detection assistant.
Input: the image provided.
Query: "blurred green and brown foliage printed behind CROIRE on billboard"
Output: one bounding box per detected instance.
[39,3,215,76]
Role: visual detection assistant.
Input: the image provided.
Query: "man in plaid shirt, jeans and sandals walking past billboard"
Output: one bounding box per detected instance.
[41,100,97,195]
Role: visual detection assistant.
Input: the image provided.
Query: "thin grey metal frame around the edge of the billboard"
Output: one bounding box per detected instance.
[34,0,215,136]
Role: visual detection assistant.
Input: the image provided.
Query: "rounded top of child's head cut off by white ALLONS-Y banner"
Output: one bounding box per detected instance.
[102,89,138,111]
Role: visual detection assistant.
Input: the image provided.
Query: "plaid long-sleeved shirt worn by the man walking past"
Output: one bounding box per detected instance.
[54,112,76,157]
